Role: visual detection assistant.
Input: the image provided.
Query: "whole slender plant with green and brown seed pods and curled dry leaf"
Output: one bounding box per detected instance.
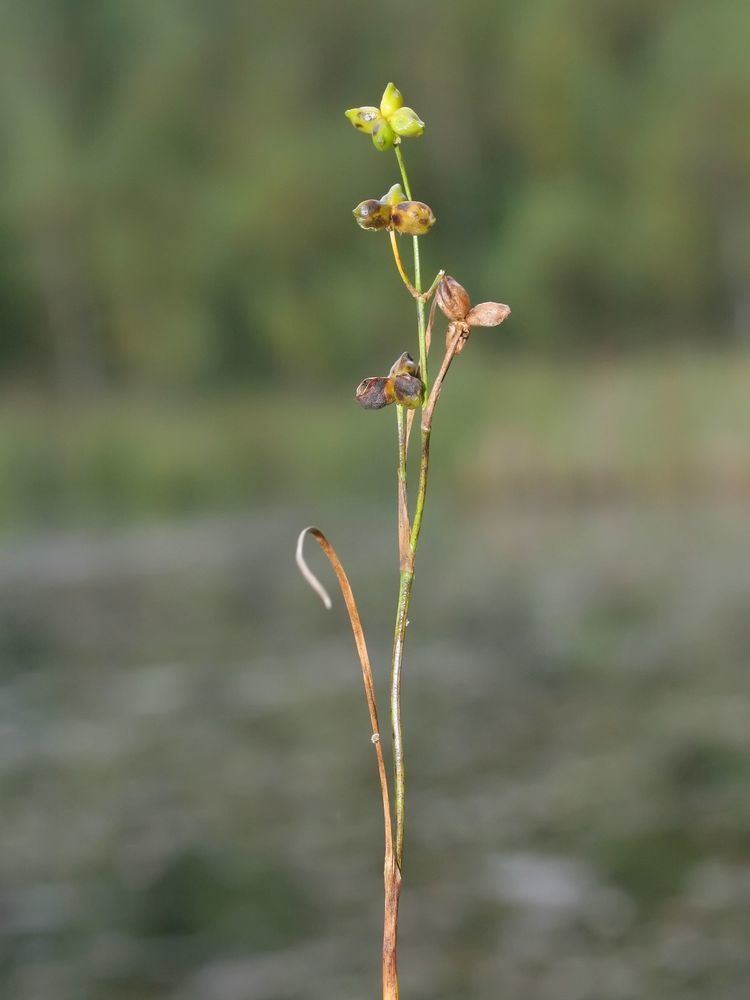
[297,83,510,1000]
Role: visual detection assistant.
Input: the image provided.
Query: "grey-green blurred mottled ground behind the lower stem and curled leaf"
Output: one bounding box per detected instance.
[0,501,750,1000]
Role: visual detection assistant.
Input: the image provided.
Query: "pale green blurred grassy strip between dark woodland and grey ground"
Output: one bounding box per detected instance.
[0,356,750,532]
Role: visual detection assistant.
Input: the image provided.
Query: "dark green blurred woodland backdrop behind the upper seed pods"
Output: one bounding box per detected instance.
[0,0,750,398]
